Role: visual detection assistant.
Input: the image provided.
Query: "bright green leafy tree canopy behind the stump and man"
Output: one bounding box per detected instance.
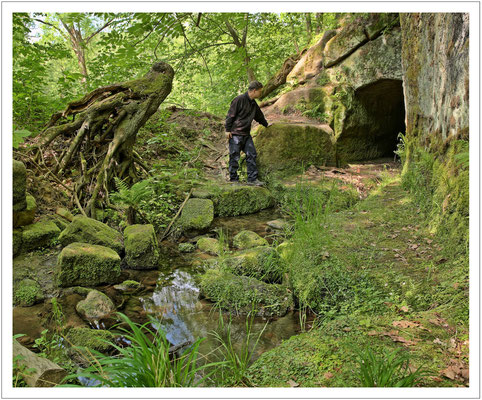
[13,13,344,131]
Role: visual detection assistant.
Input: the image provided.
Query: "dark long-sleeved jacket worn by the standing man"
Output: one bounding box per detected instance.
[225,92,268,135]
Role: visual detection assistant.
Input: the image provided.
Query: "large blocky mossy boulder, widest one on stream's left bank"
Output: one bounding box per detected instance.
[56,243,121,287]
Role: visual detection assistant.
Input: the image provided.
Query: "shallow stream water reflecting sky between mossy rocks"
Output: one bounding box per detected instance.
[140,209,300,358]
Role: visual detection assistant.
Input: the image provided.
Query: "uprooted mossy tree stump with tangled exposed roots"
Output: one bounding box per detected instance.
[29,62,174,218]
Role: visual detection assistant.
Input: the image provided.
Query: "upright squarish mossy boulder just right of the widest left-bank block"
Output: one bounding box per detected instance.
[124,224,159,269]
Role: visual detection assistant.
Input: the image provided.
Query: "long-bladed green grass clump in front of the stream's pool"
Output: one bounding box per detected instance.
[63,313,212,387]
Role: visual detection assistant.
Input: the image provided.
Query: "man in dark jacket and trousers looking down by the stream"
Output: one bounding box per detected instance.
[225,81,268,186]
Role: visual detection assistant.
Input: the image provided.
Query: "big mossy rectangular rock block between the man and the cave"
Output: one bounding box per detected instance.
[254,123,335,174]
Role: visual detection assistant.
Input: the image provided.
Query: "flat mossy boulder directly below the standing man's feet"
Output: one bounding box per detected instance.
[208,185,275,217]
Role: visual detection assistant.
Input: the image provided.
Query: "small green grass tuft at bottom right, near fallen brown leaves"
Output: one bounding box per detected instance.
[357,348,431,387]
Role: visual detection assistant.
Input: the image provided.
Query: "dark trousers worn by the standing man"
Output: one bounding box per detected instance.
[229,135,258,182]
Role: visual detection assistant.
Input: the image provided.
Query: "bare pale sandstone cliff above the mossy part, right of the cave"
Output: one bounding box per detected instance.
[400,13,469,149]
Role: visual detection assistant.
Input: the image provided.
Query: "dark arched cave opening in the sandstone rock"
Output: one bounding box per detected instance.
[337,79,405,162]
